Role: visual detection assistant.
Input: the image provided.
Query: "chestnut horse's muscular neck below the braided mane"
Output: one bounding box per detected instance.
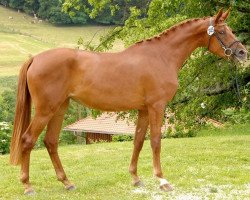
[159,19,209,70]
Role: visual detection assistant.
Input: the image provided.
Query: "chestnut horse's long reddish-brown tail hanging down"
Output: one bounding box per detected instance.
[10,58,33,165]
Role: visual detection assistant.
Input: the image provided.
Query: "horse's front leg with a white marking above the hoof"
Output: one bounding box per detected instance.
[148,102,173,191]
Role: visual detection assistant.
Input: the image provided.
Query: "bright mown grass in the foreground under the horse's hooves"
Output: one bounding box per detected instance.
[0,124,250,200]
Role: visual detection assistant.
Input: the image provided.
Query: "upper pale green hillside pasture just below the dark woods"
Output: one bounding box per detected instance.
[0,6,109,47]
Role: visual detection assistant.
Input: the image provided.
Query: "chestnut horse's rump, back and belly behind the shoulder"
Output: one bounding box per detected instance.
[25,48,143,110]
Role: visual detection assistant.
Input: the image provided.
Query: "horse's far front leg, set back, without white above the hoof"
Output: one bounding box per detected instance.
[129,109,149,186]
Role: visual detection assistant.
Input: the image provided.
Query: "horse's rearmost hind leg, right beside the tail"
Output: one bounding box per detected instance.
[20,113,52,194]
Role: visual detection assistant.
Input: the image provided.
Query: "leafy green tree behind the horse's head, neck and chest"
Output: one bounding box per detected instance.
[64,0,250,135]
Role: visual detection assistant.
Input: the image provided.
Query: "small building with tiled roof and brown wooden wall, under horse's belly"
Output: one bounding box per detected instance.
[63,114,136,144]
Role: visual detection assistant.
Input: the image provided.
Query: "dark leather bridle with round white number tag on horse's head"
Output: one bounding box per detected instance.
[207,18,240,57]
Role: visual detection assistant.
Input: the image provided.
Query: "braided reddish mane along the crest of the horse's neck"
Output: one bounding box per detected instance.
[135,17,209,44]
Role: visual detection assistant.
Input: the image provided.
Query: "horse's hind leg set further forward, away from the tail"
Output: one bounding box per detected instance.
[44,100,75,190]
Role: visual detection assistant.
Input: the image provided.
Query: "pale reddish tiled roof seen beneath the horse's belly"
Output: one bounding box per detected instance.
[63,114,136,135]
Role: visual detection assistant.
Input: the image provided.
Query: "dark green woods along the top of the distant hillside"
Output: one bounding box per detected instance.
[0,0,149,25]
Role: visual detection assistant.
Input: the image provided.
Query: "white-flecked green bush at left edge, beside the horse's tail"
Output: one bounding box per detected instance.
[0,122,11,154]
